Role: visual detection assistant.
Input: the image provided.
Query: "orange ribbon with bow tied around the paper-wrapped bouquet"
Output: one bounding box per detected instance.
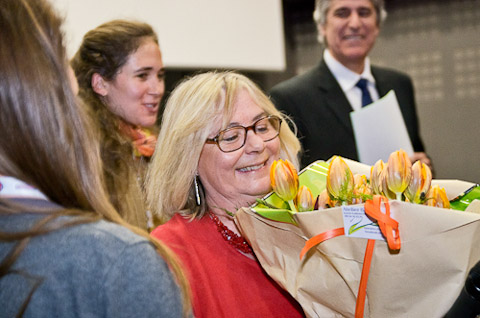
[300,195,401,318]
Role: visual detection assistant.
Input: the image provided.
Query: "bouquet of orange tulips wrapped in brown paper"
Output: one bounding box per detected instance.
[236,150,480,318]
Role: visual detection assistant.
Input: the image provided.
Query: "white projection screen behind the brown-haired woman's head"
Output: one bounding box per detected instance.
[51,0,286,71]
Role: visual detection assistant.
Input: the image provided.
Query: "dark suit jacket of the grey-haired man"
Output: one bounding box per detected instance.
[270,60,424,167]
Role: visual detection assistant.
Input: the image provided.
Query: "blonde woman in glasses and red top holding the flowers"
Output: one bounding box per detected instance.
[146,72,303,318]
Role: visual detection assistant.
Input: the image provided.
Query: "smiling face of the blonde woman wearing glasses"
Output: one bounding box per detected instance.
[198,89,280,212]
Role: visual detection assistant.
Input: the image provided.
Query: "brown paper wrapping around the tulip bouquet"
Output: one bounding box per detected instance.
[236,201,480,318]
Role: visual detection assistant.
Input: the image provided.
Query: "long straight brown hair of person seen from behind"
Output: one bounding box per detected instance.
[0,0,189,311]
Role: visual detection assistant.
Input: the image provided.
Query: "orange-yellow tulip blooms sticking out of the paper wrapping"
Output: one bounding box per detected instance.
[270,150,450,212]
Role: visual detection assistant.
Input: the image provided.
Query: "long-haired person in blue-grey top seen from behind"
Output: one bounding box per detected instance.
[0,0,189,318]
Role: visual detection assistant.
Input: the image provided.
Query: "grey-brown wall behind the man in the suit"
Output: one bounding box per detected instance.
[265,0,480,182]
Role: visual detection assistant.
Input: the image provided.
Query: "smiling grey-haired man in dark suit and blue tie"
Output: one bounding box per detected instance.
[270,0,431,166]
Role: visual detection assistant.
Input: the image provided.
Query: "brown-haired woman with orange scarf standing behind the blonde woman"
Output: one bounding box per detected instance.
[72,20,165,230]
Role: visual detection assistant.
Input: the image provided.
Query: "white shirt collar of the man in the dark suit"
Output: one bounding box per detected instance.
[323,49,375,92]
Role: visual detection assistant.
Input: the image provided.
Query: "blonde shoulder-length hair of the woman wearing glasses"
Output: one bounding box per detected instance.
[146,72,300,221]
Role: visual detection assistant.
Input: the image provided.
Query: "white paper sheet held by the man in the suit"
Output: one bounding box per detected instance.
[350,90,413,165]
